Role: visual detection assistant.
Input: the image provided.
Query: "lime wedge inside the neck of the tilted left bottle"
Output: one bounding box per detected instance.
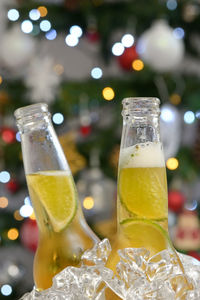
[27,171,77,232]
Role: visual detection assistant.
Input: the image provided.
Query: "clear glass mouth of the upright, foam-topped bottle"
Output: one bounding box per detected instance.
[122,97,160,116]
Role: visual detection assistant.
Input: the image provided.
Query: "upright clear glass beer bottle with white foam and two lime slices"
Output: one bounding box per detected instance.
[107,98,188,285]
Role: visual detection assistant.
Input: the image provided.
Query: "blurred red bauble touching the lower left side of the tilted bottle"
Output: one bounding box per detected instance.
[20,219,39,252]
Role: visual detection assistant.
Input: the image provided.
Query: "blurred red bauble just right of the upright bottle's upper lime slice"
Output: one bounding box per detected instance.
[168,190,185,213]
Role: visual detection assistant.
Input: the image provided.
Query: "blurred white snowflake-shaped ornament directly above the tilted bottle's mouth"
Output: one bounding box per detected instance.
[24,56,60,103]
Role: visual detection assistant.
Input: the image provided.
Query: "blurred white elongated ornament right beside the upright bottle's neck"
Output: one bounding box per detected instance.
[160,104,181,160]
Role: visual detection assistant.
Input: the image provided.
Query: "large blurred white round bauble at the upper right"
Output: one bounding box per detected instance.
[137,20,184,72]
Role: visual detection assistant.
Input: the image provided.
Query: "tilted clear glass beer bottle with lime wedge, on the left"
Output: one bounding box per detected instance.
[15,103,98,290]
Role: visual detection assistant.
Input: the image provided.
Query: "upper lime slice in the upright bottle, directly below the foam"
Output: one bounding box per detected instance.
[118,167,168,220]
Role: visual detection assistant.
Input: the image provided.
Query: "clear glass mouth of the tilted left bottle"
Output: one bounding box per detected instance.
[14,103,48,121]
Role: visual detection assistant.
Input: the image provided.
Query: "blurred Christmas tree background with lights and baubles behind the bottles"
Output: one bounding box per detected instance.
[0,0,200,299]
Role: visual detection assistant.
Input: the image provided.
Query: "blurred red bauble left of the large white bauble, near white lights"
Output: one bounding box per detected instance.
[118,46,138,71]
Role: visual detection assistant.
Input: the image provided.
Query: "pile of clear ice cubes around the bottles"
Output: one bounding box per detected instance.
[21,239,200,300]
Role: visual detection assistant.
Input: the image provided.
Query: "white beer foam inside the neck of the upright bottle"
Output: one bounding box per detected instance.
[120,142,165,168]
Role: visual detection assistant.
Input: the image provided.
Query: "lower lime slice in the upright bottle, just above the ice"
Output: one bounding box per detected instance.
[120,219,172,256]
